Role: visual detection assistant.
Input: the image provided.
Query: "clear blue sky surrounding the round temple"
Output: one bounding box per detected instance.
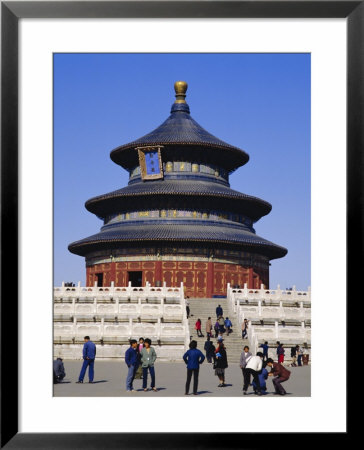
[54,53,311,290]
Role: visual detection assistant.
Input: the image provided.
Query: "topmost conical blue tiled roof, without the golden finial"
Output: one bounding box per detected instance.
[110,104,249,170]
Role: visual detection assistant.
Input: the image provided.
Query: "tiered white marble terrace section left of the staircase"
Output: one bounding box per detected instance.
[53,283,189,360]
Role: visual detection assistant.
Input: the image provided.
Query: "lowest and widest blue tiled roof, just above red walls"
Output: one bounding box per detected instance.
[68,221,287,259]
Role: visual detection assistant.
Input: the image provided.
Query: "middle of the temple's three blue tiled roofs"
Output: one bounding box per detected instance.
[86,180,272,220]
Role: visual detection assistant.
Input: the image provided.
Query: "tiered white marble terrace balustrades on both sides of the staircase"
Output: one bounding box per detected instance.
[53,283,311,361]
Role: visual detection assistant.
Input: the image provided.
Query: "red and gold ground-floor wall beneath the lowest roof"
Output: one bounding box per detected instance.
[86,261,269,297]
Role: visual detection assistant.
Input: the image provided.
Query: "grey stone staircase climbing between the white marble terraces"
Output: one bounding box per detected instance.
[188,298,249,364]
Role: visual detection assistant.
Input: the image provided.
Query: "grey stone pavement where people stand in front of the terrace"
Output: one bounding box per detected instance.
[54,360,311,398]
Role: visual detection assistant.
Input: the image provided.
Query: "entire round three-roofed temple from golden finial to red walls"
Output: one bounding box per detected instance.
[68,81,287,298]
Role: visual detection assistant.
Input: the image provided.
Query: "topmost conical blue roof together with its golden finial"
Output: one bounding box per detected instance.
[110,82,249,171]
